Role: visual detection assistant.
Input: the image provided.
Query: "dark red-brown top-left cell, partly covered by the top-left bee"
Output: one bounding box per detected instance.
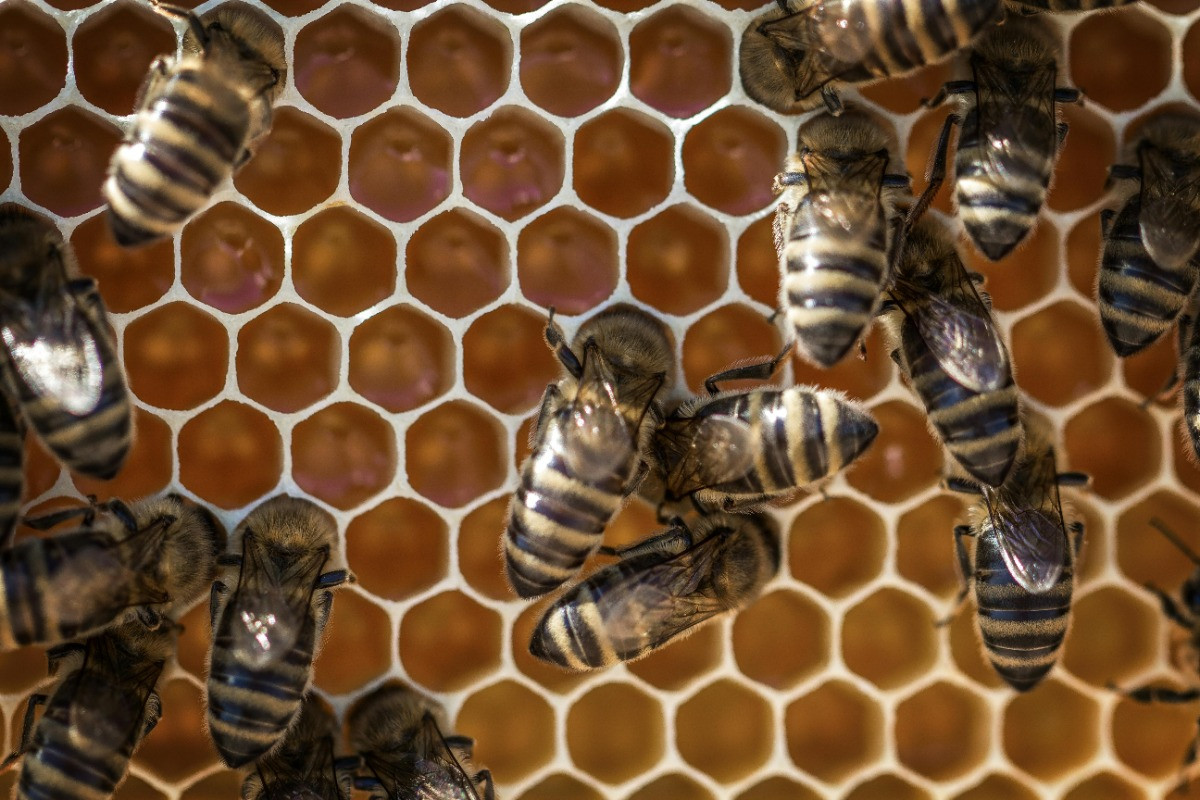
[70,2,175,114]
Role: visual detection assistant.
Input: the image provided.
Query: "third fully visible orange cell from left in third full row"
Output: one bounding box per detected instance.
[404,209,509,318]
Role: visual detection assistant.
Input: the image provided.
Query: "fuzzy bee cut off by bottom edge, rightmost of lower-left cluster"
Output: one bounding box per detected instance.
[346,680,496,800]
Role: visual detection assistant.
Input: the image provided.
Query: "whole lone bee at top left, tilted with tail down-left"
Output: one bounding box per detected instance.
[102,0,287,247]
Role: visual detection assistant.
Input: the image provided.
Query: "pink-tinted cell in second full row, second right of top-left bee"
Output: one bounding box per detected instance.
[347,107,452,222]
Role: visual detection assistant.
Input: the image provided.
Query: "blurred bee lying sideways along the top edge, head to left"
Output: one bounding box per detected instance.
[739,0,1003,114]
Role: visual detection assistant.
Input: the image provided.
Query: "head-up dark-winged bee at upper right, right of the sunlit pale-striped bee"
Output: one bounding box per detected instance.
[929,14,1080,261]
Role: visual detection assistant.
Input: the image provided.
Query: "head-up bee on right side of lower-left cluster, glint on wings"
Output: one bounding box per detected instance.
[208,495,350,768]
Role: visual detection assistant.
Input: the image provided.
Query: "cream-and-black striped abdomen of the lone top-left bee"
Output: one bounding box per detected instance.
[103,64,251,245]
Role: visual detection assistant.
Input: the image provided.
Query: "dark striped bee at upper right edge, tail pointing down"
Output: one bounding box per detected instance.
[1097,110,1200,357]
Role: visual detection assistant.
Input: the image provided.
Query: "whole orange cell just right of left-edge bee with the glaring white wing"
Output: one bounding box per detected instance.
[124,302,229,409]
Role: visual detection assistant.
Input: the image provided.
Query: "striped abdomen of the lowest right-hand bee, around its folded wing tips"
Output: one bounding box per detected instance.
[974,523,1074,692]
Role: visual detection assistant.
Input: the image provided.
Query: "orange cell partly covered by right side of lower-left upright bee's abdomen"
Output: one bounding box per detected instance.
[313,591,391,694]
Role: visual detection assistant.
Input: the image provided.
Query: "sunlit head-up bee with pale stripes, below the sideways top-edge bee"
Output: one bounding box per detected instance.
[775,108,910,367]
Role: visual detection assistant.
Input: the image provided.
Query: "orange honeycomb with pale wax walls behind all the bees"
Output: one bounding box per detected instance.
[0,0,1200,800]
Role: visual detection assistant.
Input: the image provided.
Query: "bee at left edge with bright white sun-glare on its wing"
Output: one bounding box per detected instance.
[0,204,133,482]
